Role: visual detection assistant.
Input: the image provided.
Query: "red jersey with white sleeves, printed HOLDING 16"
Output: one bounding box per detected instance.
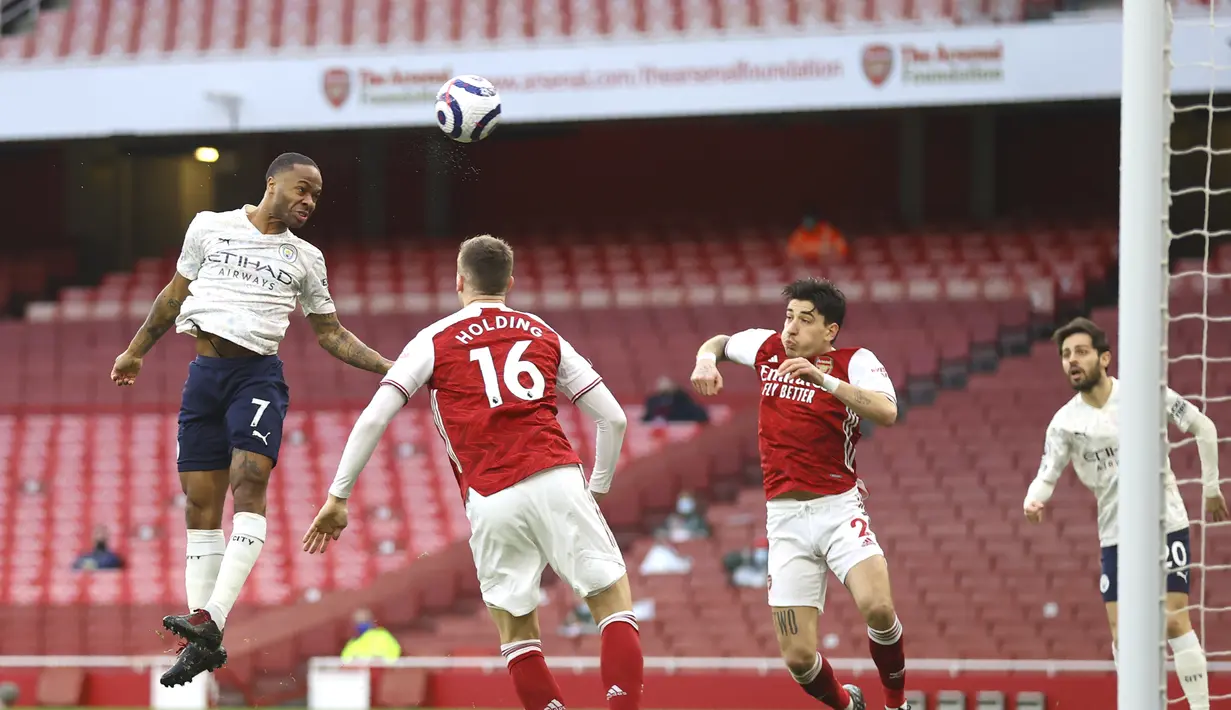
[380,303,602,500]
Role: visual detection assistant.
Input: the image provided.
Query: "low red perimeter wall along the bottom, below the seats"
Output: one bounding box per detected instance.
[0,656,1231,710]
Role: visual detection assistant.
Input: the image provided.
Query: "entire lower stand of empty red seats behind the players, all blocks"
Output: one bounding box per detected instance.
[0,229,1132,674]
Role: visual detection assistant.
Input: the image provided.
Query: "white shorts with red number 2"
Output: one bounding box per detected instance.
[766,489,885,610]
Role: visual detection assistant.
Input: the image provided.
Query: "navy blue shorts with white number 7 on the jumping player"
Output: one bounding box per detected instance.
[176,356,291,471]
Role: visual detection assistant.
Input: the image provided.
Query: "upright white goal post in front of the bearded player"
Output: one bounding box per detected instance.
[1117,0,1171,710]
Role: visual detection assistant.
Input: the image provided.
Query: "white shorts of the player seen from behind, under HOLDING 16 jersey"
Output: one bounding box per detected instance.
[465,466,625,616]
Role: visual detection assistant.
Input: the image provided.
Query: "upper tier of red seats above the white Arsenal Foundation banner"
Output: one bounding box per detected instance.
[0,0,1022,63]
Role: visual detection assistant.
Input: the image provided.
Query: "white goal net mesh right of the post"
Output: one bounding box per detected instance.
[1165,2,1231,709]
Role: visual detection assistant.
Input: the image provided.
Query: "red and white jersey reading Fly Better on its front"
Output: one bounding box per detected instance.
[726,329,897,500]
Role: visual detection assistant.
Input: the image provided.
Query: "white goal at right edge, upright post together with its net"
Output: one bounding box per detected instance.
[1117,0,1231,710]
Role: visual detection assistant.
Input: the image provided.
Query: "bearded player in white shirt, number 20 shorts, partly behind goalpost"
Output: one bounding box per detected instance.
[1023,317,1227,710]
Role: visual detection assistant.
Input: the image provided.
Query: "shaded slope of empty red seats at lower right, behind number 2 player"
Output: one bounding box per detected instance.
[329,280,1231,660]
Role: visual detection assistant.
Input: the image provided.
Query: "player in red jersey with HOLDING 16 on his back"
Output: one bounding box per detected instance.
[304,235,644,710]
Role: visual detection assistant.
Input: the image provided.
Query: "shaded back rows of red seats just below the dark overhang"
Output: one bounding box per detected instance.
[0,228,1114,411]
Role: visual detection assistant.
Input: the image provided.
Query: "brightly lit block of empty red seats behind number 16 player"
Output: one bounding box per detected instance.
[0,405,729,634]
